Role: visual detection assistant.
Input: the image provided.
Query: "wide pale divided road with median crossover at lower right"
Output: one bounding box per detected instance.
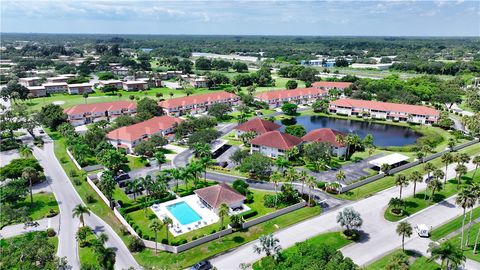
[211,157,480,269]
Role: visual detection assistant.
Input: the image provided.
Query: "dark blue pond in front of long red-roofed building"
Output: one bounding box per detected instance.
[276,116,421,147]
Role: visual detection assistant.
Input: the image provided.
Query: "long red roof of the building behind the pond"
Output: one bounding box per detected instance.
[330,98,440,116]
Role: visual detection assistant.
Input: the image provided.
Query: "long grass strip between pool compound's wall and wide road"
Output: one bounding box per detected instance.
[134,207,321,269]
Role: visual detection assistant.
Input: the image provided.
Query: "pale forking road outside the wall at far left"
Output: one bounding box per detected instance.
[33,137,140,269]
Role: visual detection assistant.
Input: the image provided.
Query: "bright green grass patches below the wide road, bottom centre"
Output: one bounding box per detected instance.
[253,232,352,270]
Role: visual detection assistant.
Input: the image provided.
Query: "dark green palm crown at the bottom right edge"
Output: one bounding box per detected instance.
[427,241,466,269]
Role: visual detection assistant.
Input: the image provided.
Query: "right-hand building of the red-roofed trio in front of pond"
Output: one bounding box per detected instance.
[302,128,347,156]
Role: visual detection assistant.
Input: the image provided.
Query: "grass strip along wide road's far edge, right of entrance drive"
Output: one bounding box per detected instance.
[337,143,480,200]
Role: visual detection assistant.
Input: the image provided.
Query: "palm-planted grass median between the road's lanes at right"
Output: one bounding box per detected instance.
[384,171,480,222]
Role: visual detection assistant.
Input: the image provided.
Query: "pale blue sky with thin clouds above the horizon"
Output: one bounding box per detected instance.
[0,0,480,36]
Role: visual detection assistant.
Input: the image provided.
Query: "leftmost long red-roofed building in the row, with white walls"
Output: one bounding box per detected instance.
[64,100,137,126]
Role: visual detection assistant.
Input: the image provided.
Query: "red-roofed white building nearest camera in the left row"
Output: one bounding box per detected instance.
[107,115,183,153]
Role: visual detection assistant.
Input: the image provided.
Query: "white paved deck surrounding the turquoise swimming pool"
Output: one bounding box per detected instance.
[150,195,219,237]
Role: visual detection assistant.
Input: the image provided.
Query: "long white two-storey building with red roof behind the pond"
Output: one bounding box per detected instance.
[329,98,440,124]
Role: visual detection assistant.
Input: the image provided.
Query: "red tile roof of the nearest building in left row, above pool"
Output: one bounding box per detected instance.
[107,115,183,141]
